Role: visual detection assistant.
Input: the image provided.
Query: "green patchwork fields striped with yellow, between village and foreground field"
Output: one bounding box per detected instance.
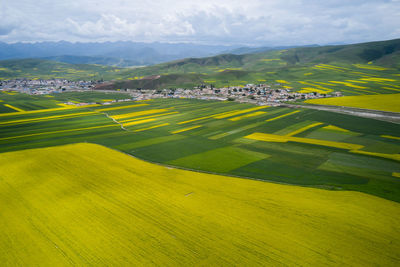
[0,93,400,202]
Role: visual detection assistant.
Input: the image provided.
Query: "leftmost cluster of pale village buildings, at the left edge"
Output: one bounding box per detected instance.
[0,79,98,95]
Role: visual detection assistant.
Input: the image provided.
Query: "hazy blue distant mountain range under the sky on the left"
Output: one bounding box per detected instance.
[0,41,237,66]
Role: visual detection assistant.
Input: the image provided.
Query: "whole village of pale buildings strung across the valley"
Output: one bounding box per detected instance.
[0,79,342,105]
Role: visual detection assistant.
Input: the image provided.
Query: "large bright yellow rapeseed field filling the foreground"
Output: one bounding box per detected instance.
[0,146,400,266]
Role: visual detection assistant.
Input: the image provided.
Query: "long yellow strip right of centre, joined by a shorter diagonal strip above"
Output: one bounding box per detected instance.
[244,133,364,152]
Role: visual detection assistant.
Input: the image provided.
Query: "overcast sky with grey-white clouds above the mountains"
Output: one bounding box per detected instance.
[0,0,400,46]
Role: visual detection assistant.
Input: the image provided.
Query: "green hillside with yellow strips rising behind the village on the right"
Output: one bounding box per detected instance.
[102,39,400,92]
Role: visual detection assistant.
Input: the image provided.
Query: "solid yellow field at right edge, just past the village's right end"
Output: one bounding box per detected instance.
[305,94,400,112]
